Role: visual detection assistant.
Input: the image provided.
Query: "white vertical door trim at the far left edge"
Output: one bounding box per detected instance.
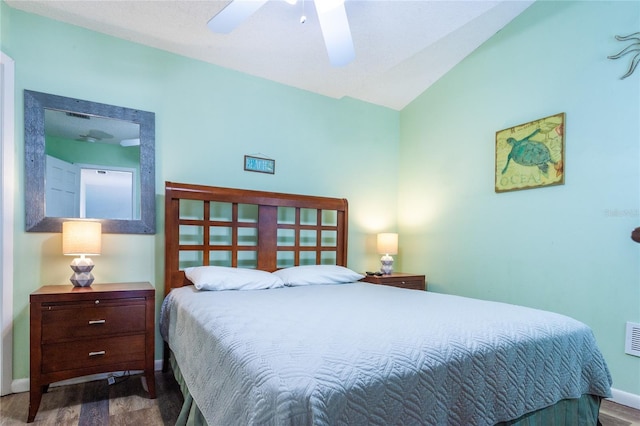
[0,52,15,395]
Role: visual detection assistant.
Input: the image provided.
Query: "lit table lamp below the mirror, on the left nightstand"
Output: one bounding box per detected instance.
[62,221,102,287]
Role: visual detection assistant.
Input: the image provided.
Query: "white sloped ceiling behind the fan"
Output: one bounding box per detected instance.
[5,0,534,110]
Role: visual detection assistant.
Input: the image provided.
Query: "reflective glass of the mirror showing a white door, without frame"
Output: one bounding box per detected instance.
[44,108,140,220]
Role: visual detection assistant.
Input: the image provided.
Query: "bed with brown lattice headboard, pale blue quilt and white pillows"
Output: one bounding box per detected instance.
[160,182,611,426]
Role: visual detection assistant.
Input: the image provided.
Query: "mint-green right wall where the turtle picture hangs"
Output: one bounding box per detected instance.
[398,1,640,395]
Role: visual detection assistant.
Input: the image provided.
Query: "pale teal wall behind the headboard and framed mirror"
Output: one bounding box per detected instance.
[0,2,400,379]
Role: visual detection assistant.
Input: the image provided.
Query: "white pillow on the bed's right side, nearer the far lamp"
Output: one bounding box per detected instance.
[272,265,364,287]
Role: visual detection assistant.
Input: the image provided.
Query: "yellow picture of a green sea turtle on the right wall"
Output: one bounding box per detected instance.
[495,113,565,192]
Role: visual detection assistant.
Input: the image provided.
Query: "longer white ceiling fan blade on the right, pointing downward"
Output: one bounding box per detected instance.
[315,0,356,67]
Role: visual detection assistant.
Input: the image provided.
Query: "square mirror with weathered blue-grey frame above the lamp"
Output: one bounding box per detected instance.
[24,90,156,234]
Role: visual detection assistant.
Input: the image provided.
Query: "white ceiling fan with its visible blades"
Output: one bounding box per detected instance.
[207,0,355,67]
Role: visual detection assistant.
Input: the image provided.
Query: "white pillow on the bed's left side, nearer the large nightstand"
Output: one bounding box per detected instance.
[184,266,284,290]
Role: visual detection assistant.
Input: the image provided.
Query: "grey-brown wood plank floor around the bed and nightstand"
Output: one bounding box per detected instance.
[0,372,640,426]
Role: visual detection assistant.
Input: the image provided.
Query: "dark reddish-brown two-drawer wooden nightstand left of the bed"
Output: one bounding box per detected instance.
[27,283,156,423]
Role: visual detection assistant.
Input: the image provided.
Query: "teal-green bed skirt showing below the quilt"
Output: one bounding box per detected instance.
[169,354,602,426]
